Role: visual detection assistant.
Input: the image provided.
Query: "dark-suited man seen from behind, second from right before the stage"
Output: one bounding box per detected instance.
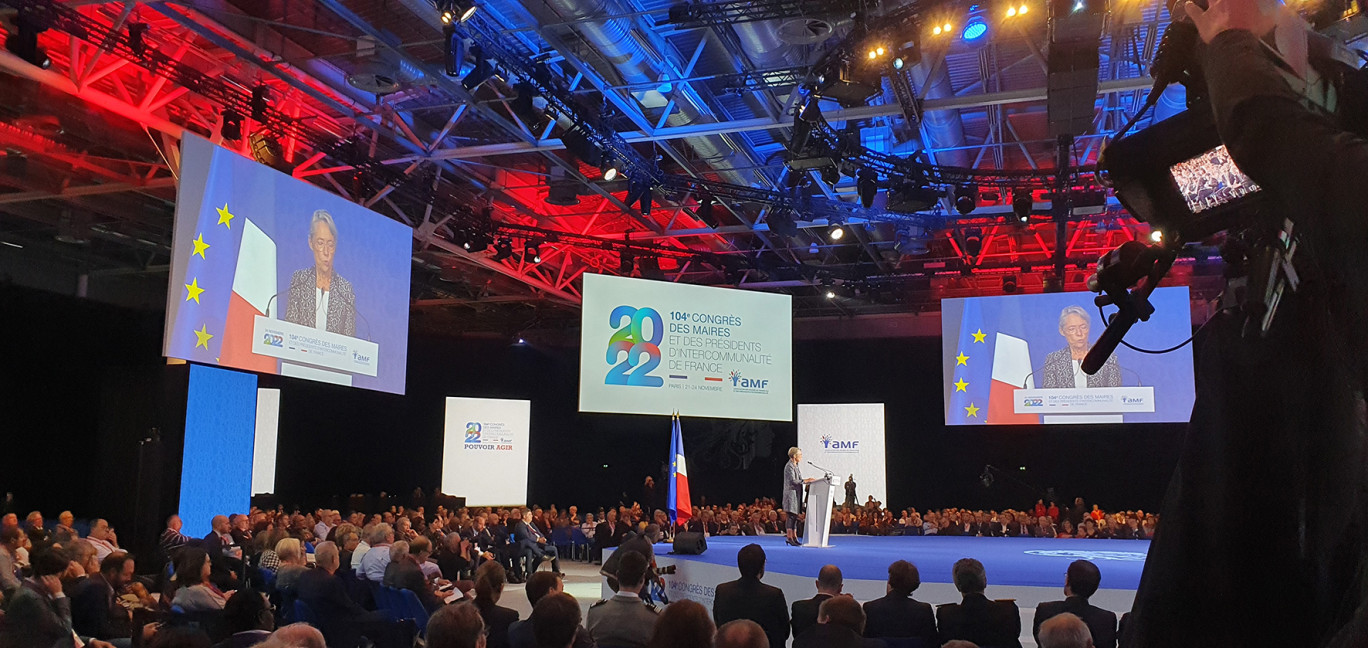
[936,558,1022,648]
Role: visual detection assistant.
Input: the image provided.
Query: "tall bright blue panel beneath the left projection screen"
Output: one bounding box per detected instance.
[179,365,256,537]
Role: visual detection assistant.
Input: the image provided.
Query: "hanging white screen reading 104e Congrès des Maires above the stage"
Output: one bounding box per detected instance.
[580,273,793,421]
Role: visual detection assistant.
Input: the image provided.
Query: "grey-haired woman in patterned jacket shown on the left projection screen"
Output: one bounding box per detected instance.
[285,209,356,336]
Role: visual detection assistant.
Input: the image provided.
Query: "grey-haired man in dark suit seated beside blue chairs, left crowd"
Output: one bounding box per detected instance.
[295,543,389,648]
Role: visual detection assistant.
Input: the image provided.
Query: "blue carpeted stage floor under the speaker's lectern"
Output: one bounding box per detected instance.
[667,536,1149,591]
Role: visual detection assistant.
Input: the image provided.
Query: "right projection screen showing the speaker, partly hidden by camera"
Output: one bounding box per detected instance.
[941,286,1194,425]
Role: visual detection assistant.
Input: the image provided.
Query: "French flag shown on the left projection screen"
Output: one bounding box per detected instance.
[219,220,285,373]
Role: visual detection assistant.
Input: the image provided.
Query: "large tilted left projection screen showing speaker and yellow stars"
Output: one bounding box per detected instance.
[163,135,413,394]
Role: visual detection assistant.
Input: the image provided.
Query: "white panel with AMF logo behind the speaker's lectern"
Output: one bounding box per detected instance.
[798,403,888,506]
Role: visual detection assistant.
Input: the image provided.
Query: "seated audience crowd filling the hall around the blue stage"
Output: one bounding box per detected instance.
[0,499,1155,648]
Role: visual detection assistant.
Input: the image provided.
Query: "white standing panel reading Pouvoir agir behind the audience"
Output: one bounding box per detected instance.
[442,396,532,506]
